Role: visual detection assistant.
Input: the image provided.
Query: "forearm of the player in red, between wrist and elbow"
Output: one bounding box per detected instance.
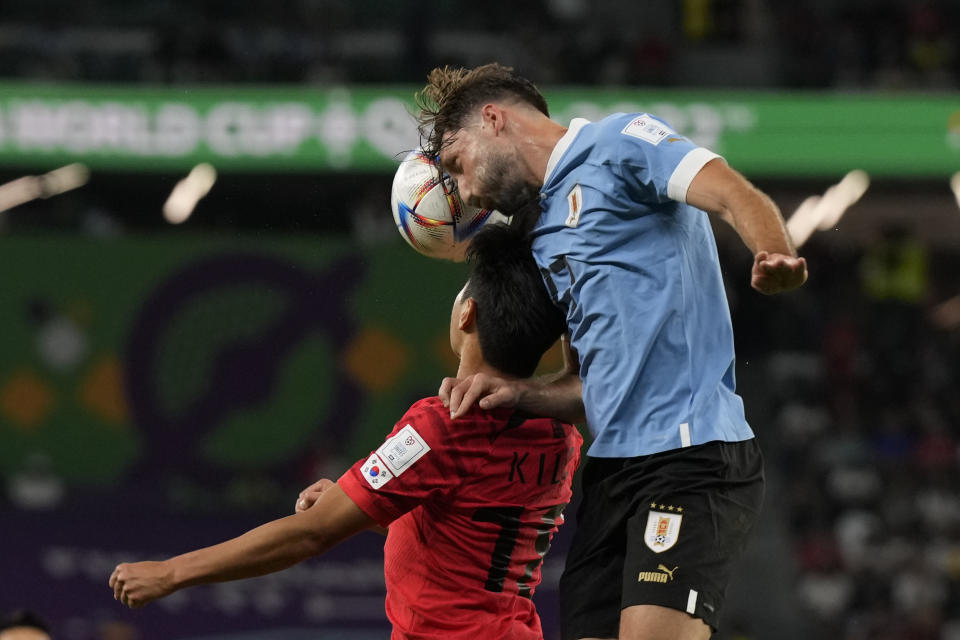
[167,514,324,589]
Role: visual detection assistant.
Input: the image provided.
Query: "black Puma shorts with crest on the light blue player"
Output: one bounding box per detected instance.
[560,438,763,640]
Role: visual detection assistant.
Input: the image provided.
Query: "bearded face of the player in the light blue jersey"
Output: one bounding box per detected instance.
[440,126,540,215]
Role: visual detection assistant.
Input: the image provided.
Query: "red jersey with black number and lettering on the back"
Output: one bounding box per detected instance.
[339,398,583,640]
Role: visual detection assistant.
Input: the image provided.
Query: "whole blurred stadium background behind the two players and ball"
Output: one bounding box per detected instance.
[0,0,960,640]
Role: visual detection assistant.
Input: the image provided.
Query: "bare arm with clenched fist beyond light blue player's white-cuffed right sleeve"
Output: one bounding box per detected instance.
[687,158,807,294]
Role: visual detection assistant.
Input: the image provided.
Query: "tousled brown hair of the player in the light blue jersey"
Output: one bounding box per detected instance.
[416,62,550,157]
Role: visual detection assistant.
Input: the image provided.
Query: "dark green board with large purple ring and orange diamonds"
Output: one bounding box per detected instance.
[0,234,488,486]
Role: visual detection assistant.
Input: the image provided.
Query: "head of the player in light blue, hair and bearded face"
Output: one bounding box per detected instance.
[417,63,549,215]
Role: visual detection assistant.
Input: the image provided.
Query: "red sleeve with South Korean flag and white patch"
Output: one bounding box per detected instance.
[337,399,462,527]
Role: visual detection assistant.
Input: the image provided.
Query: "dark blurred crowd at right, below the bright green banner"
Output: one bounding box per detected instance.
[744,227,960,640]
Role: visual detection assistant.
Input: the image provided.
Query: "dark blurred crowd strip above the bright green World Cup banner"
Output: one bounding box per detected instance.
[0,0,960,89]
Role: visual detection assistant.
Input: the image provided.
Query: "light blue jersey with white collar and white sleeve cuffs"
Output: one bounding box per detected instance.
[533,114,753,458]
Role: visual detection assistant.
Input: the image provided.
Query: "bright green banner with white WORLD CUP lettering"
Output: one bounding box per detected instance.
[0,83,960,177]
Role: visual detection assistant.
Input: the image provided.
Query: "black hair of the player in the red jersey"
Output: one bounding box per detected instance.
[464,224,567,378]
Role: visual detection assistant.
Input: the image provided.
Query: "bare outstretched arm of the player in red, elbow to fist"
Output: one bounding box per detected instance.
[110,485,376,608]
